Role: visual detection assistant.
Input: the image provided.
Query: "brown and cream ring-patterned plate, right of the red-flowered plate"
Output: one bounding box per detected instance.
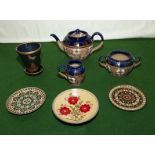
[109,85,146,111]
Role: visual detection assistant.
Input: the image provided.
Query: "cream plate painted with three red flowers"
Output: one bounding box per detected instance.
[52,89,99,124]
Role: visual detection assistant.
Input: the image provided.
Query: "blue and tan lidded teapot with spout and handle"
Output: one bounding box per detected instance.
[50,29,104,60]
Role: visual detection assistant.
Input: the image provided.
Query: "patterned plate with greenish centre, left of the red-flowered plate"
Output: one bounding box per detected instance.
[6,87,46,115]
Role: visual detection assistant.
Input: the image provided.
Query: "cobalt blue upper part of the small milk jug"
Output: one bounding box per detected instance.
[66,60,85,76]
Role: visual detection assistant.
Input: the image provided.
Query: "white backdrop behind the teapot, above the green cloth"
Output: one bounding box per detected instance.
[0,20,155,43]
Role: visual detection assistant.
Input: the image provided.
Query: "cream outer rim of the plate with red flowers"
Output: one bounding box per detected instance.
[52,88,99,124]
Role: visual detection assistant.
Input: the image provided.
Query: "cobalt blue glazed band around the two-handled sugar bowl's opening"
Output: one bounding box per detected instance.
[106,50,135,67]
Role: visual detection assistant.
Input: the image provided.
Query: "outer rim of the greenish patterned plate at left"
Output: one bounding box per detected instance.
[5,87,46,116]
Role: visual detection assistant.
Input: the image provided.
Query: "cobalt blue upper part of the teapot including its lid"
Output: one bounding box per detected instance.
[63,29,92,47]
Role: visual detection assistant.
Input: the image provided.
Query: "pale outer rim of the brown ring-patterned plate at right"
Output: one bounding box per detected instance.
[109,84,146,111]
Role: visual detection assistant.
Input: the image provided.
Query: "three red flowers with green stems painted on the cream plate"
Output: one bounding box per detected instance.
[58,93,92,121]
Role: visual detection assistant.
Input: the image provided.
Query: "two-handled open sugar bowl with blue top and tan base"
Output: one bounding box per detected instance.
[99,50,141,76]
